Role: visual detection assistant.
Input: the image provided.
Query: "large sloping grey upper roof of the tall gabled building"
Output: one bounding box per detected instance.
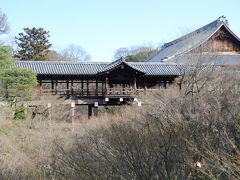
[146,16,240,62]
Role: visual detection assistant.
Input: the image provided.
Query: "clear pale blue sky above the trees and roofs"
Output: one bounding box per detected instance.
[0,0,240,62]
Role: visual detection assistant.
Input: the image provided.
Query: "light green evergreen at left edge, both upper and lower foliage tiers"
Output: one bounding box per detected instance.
[0,46,37,101]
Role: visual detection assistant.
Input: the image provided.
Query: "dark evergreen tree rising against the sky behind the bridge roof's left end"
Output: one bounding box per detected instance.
[15,27,51,60]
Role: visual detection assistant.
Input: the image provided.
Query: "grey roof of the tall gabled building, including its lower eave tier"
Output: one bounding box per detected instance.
[146,16,240,65]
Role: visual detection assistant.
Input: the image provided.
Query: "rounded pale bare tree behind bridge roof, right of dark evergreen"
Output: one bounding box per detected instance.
[60,44,91,61]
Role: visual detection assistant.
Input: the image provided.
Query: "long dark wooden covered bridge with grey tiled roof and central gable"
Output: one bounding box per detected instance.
[16,58,181,100]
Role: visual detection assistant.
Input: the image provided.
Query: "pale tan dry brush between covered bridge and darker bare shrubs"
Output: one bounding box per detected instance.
[0,68,239,179]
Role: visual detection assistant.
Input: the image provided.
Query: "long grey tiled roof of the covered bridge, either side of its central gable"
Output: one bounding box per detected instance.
[16,61,190,76]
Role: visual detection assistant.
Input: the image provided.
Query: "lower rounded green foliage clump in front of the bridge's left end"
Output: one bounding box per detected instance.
[2,67,37,101]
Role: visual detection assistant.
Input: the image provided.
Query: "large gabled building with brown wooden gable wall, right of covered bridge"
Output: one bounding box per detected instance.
[146,16,240,65]
